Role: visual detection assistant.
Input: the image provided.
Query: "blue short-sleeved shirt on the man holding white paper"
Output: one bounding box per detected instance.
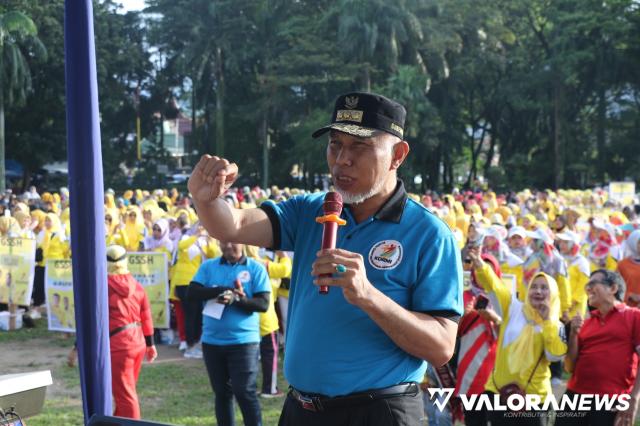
[192,256,271,345]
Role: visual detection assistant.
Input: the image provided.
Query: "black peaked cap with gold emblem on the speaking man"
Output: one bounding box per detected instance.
[311,92,407,139]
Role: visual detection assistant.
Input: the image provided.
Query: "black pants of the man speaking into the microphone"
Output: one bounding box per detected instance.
[278,392,426,426]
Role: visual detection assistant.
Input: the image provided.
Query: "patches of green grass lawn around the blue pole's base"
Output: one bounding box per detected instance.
[0,320,287,426]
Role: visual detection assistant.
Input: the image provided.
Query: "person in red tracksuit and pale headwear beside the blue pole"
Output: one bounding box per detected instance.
[107,245,158,419]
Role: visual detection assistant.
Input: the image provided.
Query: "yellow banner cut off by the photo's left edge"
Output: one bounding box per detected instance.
[0,237,36,306]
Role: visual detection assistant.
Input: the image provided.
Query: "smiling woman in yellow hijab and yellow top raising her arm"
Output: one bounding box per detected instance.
[469,250,567,426]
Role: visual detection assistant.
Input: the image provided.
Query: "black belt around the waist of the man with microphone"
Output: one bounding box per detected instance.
[289,383,420,411]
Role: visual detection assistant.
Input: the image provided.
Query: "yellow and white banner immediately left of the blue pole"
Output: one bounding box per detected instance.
[44,260,76,332]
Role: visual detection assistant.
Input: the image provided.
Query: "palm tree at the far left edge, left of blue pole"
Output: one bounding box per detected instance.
[0,11,46,192]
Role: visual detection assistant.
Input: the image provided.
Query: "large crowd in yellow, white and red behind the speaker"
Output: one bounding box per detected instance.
[0,181,640,424]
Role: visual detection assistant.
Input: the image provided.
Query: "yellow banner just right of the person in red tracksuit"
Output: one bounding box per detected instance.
[128,252,169,328]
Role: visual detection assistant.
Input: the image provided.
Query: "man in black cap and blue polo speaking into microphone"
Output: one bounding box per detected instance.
[189,93,462,426]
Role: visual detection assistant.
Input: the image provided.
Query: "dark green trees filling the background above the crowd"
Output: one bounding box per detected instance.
[0,0,640,190]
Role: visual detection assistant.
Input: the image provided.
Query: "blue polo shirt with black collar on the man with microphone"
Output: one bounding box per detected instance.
[261,181,462,396]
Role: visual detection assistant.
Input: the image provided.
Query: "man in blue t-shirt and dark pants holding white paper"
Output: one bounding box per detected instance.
[187,241,271,426]
